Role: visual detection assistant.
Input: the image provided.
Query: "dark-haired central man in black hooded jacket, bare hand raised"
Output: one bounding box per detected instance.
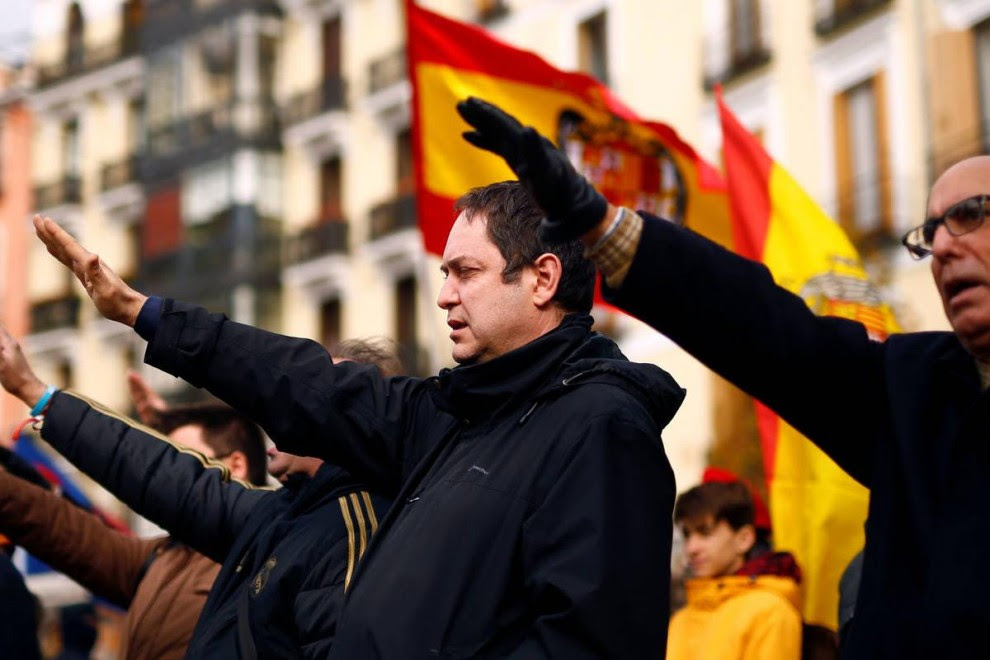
[36,182,684,658]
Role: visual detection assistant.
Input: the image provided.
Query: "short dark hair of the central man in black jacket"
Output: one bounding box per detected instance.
[454,181,595,313]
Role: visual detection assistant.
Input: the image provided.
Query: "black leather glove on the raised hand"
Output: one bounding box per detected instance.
[457,96,608,243]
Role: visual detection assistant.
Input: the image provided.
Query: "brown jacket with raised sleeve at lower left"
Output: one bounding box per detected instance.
[0,470,220,660]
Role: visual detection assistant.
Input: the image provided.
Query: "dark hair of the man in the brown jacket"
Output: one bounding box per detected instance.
[155,403,266,486]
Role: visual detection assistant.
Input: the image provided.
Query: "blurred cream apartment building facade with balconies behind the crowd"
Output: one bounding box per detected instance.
[26,0,990,500]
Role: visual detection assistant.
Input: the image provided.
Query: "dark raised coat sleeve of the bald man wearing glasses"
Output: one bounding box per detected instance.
[603,214,886,486]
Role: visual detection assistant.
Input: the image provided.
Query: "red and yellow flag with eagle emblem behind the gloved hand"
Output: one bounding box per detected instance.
[406,0,730,254]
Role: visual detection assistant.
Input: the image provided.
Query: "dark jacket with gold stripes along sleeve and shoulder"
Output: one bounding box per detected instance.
[42,392,389,658]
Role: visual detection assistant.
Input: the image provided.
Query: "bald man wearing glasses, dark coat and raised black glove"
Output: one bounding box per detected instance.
[458,99,990,658]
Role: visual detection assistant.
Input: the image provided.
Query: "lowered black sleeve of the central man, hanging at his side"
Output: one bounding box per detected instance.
[508,404,674,659]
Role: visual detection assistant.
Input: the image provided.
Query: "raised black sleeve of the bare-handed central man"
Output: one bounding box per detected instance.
[145,300,430,493]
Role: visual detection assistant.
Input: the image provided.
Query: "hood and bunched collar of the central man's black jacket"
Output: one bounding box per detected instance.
[430,314,684,428]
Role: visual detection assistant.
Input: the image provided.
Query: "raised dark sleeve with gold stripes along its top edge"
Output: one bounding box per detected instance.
[41,392,268,563]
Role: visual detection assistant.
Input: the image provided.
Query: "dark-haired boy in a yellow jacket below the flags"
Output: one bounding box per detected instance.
[667,481,801,660]
